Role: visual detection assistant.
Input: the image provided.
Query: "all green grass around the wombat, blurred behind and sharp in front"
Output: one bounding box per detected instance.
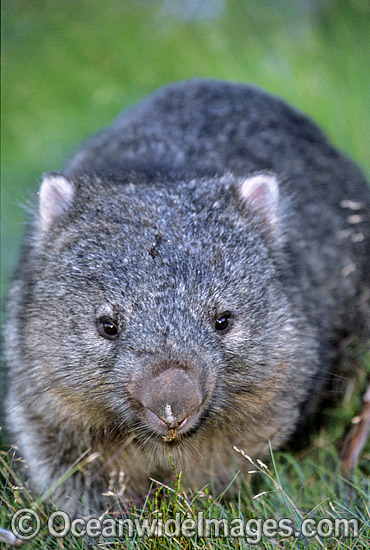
[0,0,370,550]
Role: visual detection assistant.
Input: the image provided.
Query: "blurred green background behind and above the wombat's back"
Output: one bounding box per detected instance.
[1,0,370,304]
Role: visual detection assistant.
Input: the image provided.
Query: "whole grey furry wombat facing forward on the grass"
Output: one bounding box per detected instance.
[5,79,370,514]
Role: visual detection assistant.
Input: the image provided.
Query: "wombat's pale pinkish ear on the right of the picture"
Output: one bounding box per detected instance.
[238,172,279,232]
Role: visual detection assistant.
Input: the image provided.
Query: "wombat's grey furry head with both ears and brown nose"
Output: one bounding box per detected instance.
[9,173,316,464]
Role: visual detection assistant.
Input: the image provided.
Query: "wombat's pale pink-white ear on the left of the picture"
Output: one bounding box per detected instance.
[38,172,74,231]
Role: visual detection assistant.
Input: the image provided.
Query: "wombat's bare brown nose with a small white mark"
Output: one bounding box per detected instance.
[137,368,202,434]
